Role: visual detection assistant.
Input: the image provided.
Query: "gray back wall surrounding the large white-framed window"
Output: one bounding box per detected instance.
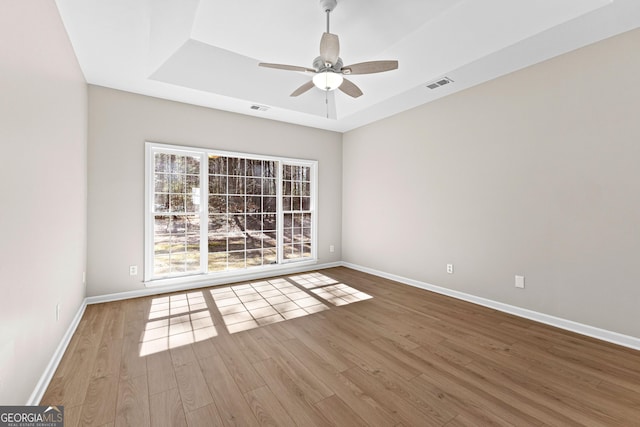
[87,86,342,296]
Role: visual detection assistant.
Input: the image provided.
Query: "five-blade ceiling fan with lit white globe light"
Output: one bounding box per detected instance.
[258,0,398,98]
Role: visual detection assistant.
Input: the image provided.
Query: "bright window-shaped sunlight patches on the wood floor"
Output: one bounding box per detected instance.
[140,273,373,346]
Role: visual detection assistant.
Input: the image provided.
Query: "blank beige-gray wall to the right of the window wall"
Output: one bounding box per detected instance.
[342,30,640,337]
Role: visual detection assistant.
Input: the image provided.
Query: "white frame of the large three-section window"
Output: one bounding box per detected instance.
[144,141,318,286]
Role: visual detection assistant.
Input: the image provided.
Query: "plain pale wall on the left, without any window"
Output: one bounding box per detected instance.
[0,0,87,405]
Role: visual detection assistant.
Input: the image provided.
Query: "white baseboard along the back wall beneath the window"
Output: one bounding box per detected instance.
[86,262,343,304]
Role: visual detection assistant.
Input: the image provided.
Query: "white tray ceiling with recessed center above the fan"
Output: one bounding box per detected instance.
[56,0,640,132]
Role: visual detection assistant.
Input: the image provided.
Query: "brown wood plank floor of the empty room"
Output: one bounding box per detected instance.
[41,267,640,427]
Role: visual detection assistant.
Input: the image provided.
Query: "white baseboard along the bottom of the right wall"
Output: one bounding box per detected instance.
[342,262,640,350]
